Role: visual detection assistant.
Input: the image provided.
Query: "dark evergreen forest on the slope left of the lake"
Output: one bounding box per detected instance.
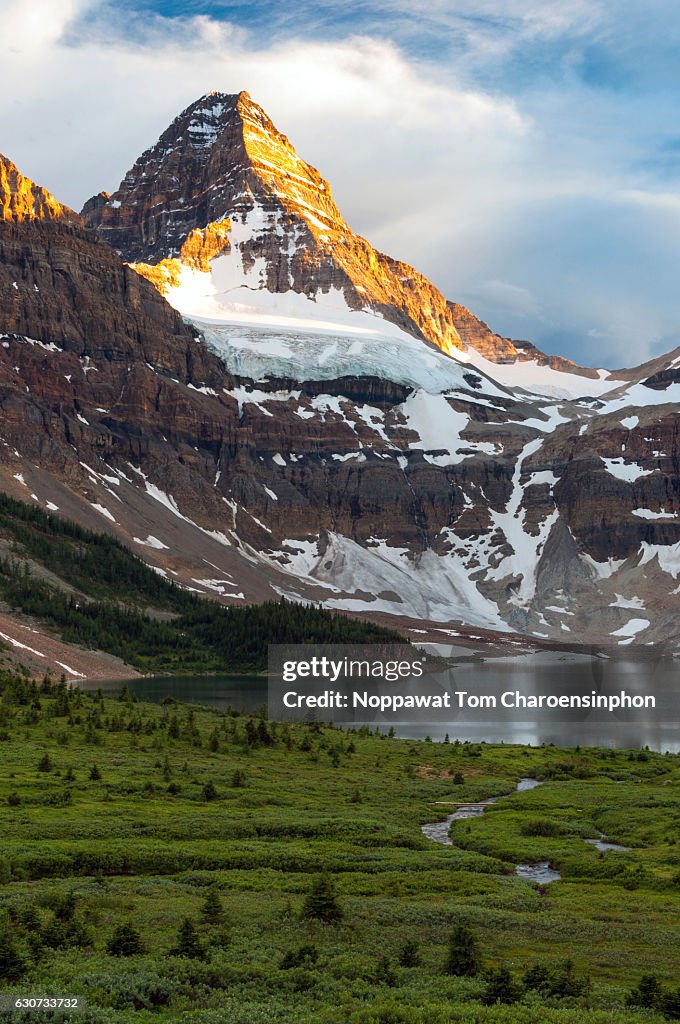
[0,494,403,672]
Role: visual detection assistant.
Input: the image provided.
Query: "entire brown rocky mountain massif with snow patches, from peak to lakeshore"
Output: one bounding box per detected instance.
[0,108,680,649]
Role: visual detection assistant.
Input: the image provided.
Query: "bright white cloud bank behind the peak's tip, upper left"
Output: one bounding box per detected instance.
[0,0,528,221]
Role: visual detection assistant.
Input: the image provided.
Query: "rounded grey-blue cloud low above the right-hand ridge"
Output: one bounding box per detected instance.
[440,194,680,367]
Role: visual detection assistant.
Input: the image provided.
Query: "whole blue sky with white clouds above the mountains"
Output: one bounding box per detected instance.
[0,0,680,368]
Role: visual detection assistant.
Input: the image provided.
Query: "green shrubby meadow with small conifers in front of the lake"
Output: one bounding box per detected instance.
[0,674,680,1024]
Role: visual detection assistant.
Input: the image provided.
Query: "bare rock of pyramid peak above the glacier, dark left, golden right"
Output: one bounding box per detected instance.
[83,92,463,353]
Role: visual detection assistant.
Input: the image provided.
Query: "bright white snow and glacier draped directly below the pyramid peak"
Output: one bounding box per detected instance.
[157,204,622,399]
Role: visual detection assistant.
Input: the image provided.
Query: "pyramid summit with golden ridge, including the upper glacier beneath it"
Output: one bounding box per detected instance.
[82,92,639,396]
